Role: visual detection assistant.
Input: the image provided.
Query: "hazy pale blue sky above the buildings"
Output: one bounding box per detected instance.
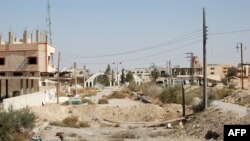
[0,0,250,72]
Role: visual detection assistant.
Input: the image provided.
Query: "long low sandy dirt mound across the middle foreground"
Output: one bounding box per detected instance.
[32,104,166,126]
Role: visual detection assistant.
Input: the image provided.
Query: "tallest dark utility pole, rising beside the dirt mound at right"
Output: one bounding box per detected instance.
[203,8,207,111]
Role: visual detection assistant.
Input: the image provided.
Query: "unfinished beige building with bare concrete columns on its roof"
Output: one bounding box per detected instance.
[0,30,56,99]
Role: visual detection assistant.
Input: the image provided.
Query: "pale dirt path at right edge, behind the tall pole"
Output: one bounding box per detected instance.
[212,100,249,116]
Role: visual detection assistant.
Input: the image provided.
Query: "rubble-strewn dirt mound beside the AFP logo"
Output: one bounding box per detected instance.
[185,108,250,140]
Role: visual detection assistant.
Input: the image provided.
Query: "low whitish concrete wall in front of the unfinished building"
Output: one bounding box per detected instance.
[3,89,56,110]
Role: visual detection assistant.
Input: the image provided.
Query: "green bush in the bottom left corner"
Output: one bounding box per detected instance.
[0,107,36,141]
